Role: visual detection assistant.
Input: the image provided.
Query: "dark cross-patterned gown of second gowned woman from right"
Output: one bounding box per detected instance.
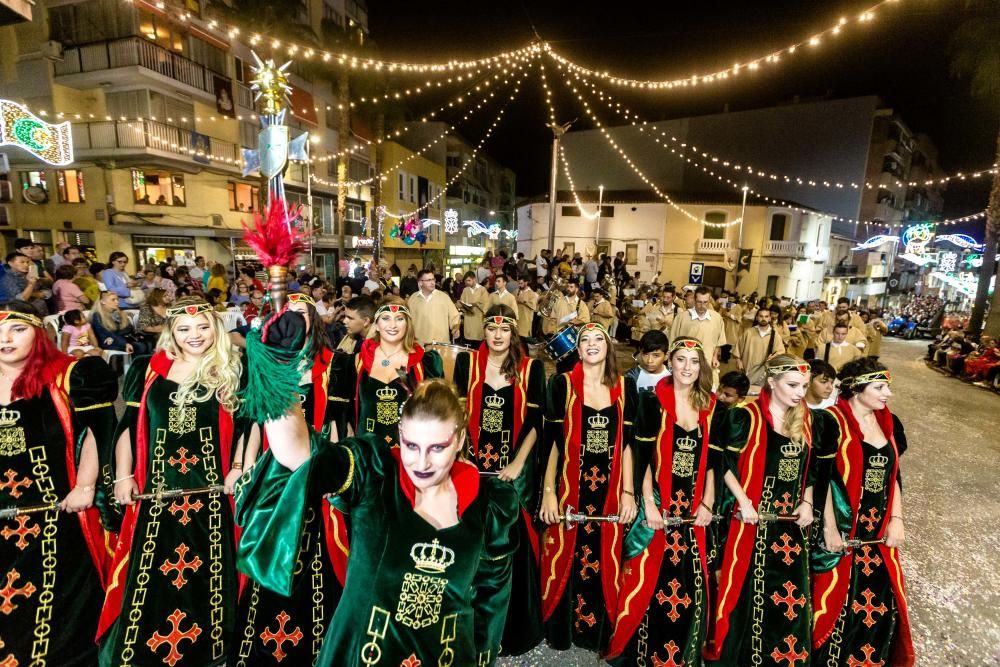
[709,408,820,667]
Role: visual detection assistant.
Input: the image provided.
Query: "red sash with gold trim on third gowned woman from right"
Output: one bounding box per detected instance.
[607,377,718,657]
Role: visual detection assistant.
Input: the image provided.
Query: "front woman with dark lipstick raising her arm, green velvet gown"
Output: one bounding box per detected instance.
[238,334,519,667]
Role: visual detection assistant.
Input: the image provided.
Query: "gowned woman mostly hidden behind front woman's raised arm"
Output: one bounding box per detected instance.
[231,293,347,667]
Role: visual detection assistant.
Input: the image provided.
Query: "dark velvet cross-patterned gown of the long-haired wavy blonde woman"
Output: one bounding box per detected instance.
[100,358,239,667]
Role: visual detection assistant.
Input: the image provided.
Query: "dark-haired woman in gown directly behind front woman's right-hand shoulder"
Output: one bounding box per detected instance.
[455,305,545,655]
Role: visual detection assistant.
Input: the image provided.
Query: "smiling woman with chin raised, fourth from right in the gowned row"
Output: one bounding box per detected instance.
[539,322,641,652]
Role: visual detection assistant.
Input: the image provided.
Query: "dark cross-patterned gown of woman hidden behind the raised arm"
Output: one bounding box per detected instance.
[230,352,346,667]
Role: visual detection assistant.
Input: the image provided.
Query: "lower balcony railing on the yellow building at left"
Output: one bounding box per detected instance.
[72,120,240,167]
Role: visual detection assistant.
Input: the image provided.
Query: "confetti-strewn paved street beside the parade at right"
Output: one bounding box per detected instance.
[498,339,1000,667]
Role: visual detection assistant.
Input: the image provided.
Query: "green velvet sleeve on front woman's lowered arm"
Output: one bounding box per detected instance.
[472,479,520,666]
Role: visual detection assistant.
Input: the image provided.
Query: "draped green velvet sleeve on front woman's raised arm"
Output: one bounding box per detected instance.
[234,431,383,596]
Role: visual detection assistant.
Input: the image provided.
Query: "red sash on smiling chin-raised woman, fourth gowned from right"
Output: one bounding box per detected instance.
[542,363,625,621]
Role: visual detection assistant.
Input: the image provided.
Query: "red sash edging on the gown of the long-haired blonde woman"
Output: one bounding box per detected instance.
[97,350,236,639]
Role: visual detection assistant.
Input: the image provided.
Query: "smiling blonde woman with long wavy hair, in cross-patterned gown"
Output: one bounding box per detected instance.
[98,298,260,667]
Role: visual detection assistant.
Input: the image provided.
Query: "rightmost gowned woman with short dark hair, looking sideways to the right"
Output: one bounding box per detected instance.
[811,357,915,667]
